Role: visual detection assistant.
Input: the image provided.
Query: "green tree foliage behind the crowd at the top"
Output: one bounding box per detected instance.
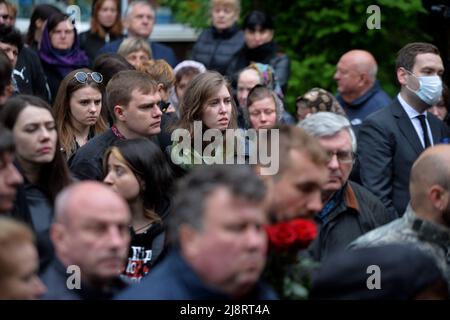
[160,0,431,111]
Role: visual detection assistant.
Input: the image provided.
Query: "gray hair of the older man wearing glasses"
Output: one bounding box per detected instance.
[297,112,356,152]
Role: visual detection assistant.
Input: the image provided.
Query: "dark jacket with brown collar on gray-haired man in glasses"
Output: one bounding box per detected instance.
[307,181,396,261]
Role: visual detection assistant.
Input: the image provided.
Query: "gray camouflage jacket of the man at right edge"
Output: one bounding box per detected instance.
[349,205,450,288]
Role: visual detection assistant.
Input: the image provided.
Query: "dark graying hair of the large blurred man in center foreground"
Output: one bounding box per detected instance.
[168,165,266,245]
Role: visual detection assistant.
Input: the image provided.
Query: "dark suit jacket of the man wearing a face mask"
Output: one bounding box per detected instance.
[358,98,450,216]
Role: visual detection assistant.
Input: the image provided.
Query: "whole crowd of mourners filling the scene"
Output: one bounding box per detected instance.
[0,0,450,300]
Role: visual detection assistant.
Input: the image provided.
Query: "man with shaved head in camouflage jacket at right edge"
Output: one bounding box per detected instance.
[350,144,450,287]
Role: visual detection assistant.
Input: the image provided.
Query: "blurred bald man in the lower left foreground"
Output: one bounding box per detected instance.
[42,181,130,300]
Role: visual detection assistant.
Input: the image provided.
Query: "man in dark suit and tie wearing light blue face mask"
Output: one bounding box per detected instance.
[358,42,450,216]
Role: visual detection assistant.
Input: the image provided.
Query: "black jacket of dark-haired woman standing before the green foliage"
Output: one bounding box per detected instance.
[226,41,291,92]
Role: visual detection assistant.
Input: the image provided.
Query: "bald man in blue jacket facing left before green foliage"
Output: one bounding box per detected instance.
[334,50,391,126]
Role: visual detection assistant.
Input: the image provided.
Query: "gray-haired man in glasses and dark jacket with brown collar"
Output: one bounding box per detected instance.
[298,112,394,261]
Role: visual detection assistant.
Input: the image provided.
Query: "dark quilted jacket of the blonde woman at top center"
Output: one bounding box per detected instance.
[192,25,244,75]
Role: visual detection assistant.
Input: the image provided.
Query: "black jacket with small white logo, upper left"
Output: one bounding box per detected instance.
[13,46,50,101]
